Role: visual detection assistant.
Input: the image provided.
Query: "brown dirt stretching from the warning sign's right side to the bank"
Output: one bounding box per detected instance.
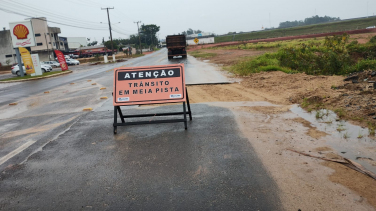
[188,71,376,129]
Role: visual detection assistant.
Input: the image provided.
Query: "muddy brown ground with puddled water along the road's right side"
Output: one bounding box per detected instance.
[188,34,376,210]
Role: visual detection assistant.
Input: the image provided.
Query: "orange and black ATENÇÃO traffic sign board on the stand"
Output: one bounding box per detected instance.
[113,64,186,106]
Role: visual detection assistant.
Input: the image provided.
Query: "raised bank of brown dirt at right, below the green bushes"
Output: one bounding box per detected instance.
[242,71,376,126]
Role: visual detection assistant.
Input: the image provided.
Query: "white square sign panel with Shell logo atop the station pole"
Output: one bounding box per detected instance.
[9,20,35,48]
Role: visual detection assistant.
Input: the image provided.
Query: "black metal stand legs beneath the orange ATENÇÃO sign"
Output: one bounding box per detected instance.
[113,88,192,134]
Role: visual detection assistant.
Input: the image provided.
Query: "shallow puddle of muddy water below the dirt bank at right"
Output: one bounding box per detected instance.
[290,105,376,173]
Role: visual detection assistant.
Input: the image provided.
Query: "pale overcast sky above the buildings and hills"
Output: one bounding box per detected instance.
[0,0,376,41]
